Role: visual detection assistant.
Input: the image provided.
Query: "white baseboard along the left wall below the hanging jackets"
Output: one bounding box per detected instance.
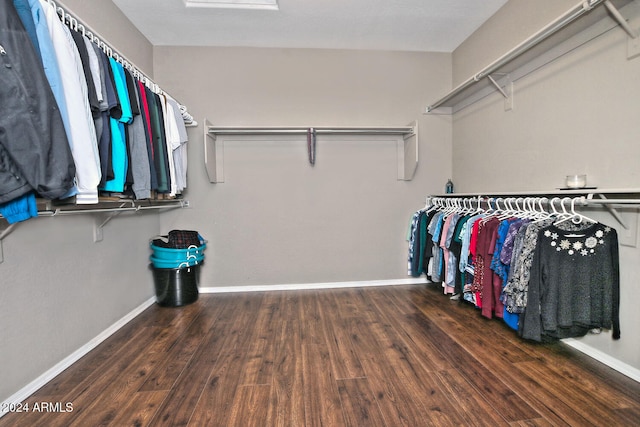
[0,296,156,418]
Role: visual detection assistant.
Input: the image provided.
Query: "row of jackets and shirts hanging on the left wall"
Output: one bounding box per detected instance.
[0,0,193,226]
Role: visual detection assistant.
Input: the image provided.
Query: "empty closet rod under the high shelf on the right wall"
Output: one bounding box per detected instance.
[427,0,604,113]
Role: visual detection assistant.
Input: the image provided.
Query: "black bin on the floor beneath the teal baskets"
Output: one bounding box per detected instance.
[151,265,200,307]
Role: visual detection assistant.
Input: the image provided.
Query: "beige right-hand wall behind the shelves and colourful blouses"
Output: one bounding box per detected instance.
[453,0,640,369]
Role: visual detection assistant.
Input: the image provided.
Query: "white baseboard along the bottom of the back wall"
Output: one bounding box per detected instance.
[199,278,430,294]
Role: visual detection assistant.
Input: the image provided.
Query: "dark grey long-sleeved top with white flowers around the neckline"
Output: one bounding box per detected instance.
[520,223,620,341]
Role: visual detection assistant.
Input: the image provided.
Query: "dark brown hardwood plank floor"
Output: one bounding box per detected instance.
[0,286,640,427]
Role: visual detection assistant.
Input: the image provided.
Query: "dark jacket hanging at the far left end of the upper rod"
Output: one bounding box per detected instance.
[0,0,75,203]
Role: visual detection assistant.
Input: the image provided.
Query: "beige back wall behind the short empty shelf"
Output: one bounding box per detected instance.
[154,47,451,287]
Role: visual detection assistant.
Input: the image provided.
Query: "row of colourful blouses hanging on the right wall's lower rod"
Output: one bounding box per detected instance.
[409,198,620,341]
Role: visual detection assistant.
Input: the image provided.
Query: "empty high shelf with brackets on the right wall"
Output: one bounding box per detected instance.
[426,0,640,114]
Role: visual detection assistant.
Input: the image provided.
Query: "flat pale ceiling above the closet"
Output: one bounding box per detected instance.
[112,0,507,52]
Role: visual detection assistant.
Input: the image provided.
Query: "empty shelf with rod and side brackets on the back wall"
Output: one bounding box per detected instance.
[204,119,418,183]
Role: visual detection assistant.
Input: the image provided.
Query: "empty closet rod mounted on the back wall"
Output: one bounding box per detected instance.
[208,126,415,135]
